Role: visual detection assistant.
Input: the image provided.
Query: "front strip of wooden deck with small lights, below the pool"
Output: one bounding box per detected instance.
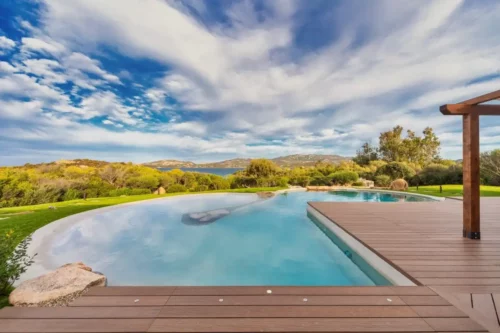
[0,287,485,332]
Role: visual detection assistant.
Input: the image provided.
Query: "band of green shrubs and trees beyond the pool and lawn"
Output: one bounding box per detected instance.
[0,126,500,207]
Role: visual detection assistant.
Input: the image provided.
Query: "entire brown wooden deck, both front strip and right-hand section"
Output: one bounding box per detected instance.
[0,199,500,333]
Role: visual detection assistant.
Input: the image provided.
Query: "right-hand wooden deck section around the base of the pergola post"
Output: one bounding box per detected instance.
[310,198,500,331]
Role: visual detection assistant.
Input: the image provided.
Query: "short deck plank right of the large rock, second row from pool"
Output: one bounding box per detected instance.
[70,296,170,306]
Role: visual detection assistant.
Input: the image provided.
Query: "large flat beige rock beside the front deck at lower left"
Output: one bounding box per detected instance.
[9,262,106,306]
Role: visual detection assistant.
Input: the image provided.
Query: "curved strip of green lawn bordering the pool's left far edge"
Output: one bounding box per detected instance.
[0,187,284,241]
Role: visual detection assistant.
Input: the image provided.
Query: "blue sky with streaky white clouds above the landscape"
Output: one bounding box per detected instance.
[0,0,500,165]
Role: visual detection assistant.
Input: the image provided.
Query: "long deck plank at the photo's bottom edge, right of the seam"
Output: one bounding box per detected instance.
[149,318,434,332]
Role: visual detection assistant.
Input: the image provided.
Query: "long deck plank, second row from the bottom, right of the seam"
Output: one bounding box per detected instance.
[158,305,418,318]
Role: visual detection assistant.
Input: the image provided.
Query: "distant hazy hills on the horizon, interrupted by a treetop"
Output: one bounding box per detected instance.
[144,154,350,168]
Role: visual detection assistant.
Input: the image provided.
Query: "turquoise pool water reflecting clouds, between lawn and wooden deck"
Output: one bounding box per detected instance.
[39,192,434,286]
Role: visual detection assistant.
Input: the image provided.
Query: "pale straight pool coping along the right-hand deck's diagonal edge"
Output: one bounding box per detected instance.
[307,205,416,286]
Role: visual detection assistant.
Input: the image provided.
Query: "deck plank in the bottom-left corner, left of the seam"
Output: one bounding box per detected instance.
[0,318,154,333]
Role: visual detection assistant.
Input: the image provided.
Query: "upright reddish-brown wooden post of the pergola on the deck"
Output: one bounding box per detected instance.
[463,113,481,239]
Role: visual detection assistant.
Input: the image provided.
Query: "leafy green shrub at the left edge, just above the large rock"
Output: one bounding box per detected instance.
[0,230,36,295]
